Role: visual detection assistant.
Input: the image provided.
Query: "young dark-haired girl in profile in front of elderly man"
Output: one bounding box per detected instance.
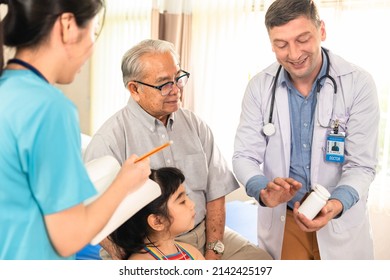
[109,167,204,260]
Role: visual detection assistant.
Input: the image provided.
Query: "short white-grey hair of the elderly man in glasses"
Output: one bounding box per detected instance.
[122,39,179,87]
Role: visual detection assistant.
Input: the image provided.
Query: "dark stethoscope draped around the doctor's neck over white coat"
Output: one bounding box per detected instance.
[263,48,337,137]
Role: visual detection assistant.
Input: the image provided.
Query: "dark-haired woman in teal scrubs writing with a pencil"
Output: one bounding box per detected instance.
[0,0,150,260]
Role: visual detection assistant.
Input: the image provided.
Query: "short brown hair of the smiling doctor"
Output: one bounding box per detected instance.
[265,0,321,32]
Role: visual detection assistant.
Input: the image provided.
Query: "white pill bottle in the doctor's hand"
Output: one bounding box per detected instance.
[298,184,330,220]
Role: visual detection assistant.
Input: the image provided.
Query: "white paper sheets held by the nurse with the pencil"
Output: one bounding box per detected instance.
[85,156,161,245]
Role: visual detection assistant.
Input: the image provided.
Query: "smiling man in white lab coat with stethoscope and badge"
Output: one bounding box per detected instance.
[233,0,379,259]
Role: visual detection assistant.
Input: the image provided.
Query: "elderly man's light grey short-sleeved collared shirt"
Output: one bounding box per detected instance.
[84,97,239,224]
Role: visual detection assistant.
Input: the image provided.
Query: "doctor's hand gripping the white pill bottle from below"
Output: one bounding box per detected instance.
[293,199,343,232]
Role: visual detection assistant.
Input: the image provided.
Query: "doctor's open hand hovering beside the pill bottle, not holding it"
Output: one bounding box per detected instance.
[260,177,302,208]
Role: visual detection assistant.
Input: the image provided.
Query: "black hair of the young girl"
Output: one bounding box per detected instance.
[108,167,185,259]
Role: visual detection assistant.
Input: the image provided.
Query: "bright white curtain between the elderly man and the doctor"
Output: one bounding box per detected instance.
[191,0,273,165]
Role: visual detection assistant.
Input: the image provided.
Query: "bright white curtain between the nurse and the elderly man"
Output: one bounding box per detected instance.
[91,0,152,134]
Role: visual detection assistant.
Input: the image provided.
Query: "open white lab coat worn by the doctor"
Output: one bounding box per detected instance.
[233,50,379,259]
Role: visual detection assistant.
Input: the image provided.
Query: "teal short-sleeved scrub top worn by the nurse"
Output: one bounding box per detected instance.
[0,70,96,260]
